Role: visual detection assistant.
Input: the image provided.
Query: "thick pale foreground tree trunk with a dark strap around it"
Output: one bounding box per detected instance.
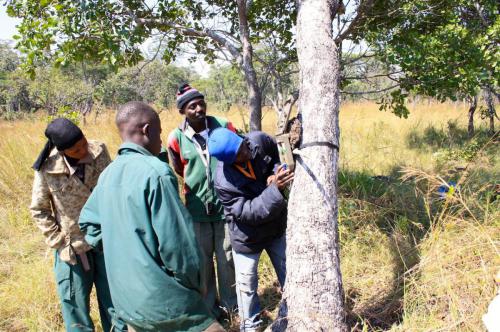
[273,0,347,331]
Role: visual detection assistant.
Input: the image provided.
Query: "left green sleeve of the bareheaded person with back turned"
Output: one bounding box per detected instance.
[78,187,102,248]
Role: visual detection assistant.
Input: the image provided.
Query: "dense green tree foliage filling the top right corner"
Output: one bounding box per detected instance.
[364,0,500,135]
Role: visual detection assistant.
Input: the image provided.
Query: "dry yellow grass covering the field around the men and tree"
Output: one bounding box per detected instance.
[0,102,500,331]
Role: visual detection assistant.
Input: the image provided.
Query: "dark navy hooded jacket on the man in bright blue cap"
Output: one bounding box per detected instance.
[215,131,287,253]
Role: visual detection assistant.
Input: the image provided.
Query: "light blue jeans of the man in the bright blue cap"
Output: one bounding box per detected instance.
[233,235,286,332]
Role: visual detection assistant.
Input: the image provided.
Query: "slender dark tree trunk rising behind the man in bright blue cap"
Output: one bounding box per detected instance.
[238,0,262,131]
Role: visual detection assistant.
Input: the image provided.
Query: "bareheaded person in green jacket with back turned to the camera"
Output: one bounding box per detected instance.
[79,102,224,332]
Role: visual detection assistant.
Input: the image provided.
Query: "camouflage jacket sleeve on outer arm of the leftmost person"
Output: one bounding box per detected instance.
[30,171,64,249]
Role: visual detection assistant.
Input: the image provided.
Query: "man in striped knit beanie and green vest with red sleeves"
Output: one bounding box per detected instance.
[167,84,237,317]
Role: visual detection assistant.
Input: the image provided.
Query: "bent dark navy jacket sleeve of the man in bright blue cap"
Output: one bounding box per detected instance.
[215,184,287,225]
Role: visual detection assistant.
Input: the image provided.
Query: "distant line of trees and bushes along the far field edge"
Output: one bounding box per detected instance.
[0,26,498,136]
